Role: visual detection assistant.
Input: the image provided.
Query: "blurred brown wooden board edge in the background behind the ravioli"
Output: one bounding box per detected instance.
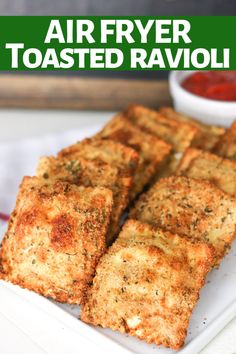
[0,75,171,110]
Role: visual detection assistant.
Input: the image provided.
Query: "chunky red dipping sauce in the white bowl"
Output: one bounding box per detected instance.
[181,71,236,101]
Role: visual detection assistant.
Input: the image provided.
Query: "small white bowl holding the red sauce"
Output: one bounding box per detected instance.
[169,71,236,126]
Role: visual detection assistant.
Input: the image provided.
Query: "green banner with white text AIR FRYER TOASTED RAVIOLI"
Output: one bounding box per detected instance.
[0,16,236,71]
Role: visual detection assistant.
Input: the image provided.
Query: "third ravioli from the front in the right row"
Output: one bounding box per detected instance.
[176,148,236,196]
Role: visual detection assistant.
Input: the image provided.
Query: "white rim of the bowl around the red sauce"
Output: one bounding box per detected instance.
[169,70,236,108]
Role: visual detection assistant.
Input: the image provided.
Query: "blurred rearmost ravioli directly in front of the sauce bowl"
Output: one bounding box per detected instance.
[159,107,225,150]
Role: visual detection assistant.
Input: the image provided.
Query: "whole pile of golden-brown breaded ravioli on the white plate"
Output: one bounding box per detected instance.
[0,105,236,350]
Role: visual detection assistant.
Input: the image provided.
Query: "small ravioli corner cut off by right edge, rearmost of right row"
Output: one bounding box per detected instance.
[213,121,236,161]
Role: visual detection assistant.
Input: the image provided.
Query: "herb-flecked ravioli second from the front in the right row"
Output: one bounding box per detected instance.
[130,176,236,265]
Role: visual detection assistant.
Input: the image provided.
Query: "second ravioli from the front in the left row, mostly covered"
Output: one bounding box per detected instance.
[37,156,132,244]
